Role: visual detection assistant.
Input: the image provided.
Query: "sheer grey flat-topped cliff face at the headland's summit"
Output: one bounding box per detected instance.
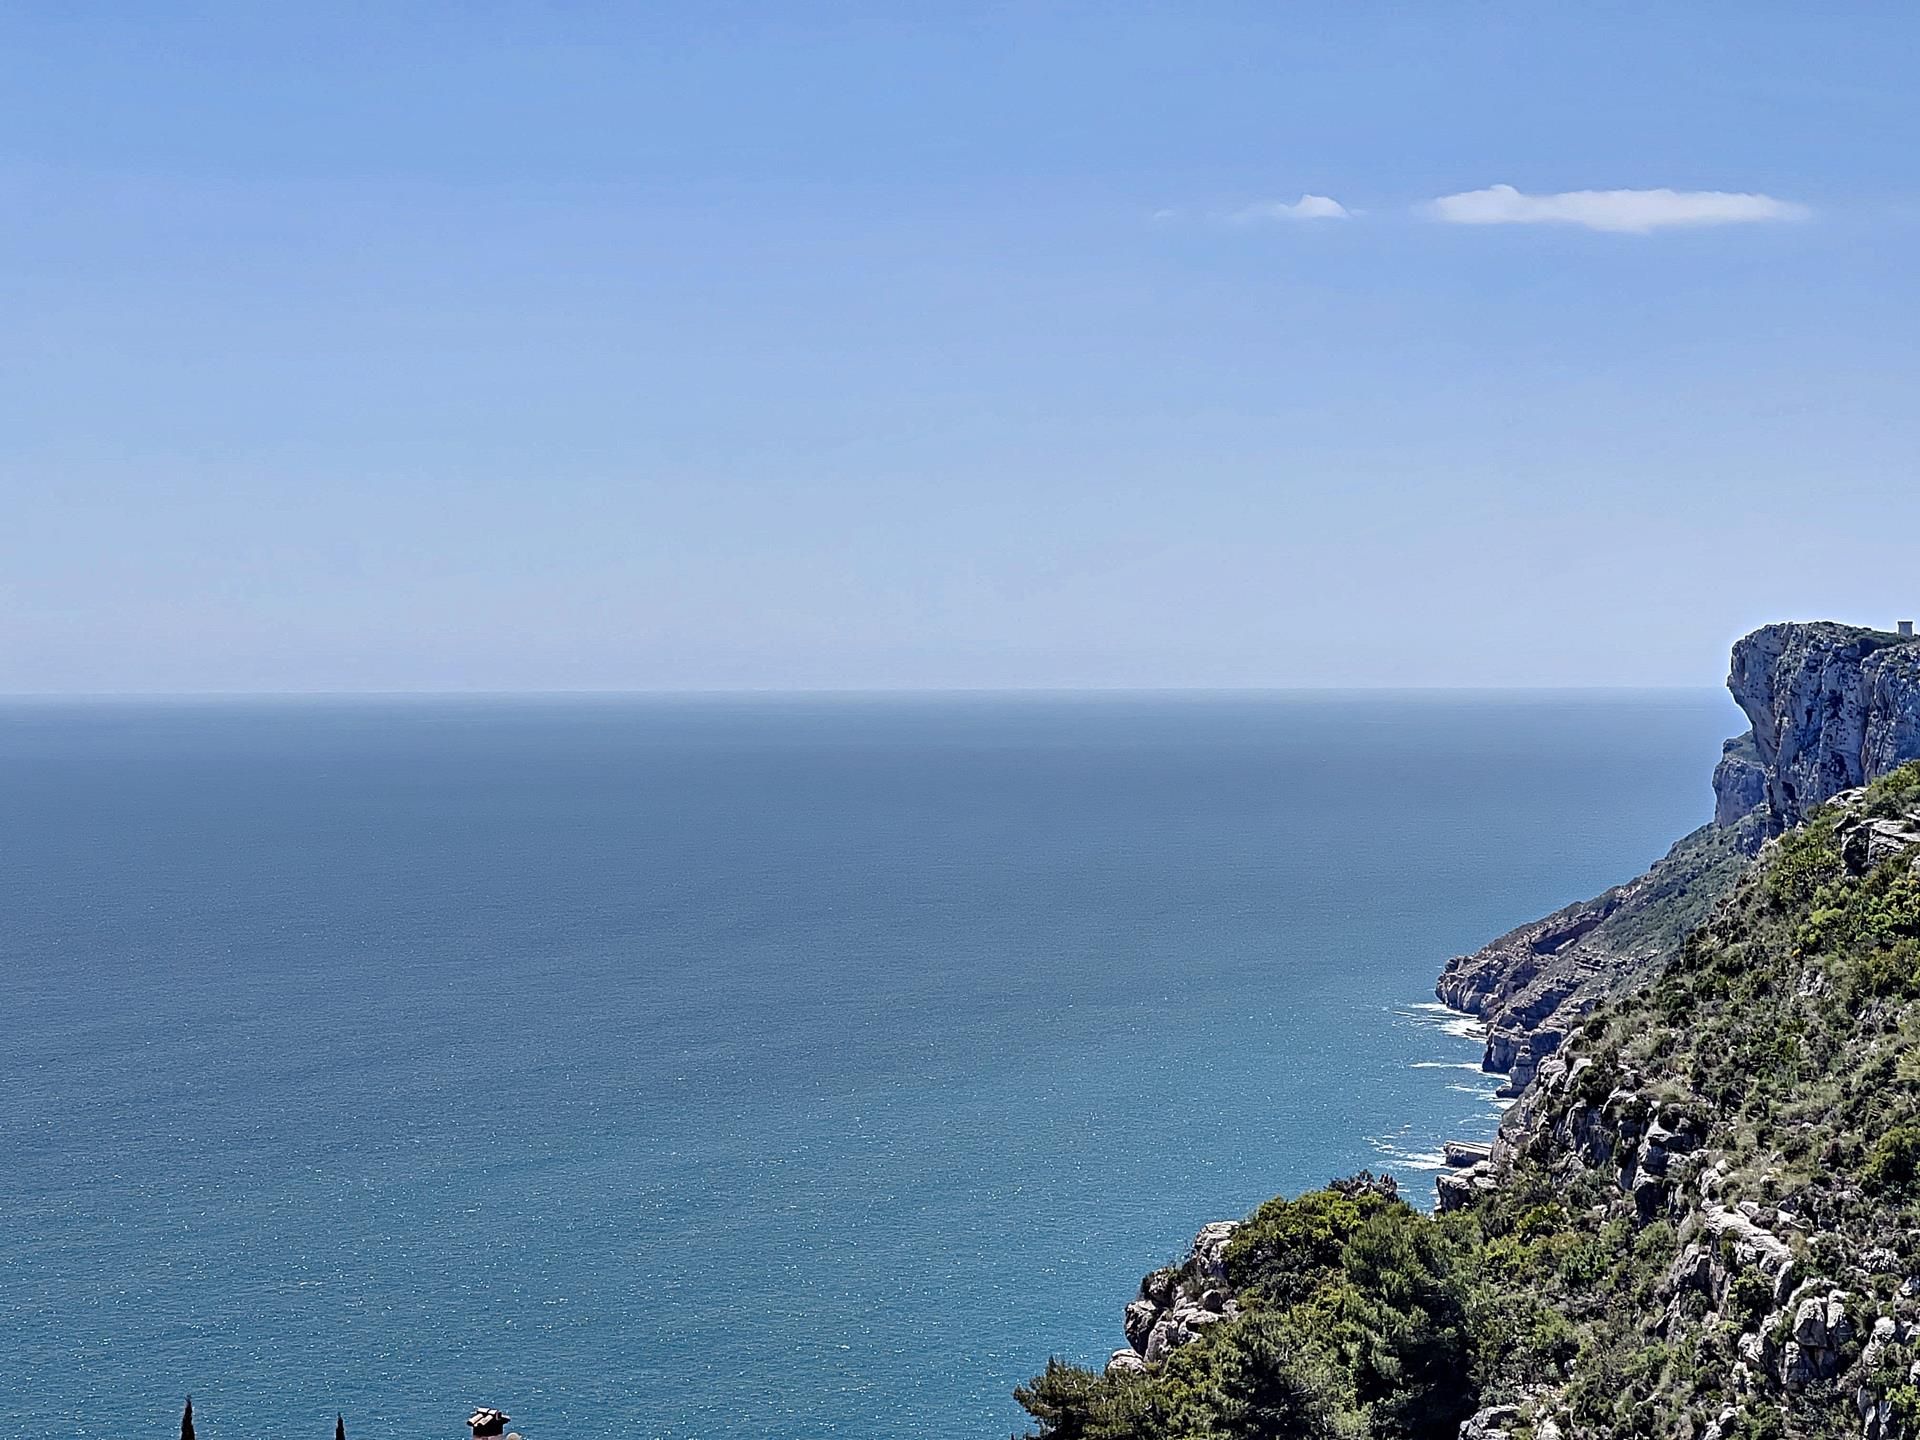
[1726,622,1920,833]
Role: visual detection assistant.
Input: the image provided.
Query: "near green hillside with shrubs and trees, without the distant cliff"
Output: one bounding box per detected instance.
[1018,764,1920,1440]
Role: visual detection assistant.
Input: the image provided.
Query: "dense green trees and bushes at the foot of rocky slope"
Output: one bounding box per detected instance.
[1018,1188,1612,1440]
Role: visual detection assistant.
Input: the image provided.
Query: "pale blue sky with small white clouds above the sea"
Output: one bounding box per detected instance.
[0,0,1920,691]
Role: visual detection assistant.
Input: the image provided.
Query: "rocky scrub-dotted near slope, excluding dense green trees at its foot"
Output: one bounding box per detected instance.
[1440,771,1920,1440]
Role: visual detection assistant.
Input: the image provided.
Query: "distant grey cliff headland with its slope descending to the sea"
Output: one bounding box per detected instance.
[1436,622,1920,1094]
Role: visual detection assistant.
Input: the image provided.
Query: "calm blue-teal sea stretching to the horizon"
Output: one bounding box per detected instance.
[0,693,1736,1440]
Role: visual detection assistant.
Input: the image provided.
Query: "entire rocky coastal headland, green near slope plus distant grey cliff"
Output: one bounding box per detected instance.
[1018,622,1920,1440]
